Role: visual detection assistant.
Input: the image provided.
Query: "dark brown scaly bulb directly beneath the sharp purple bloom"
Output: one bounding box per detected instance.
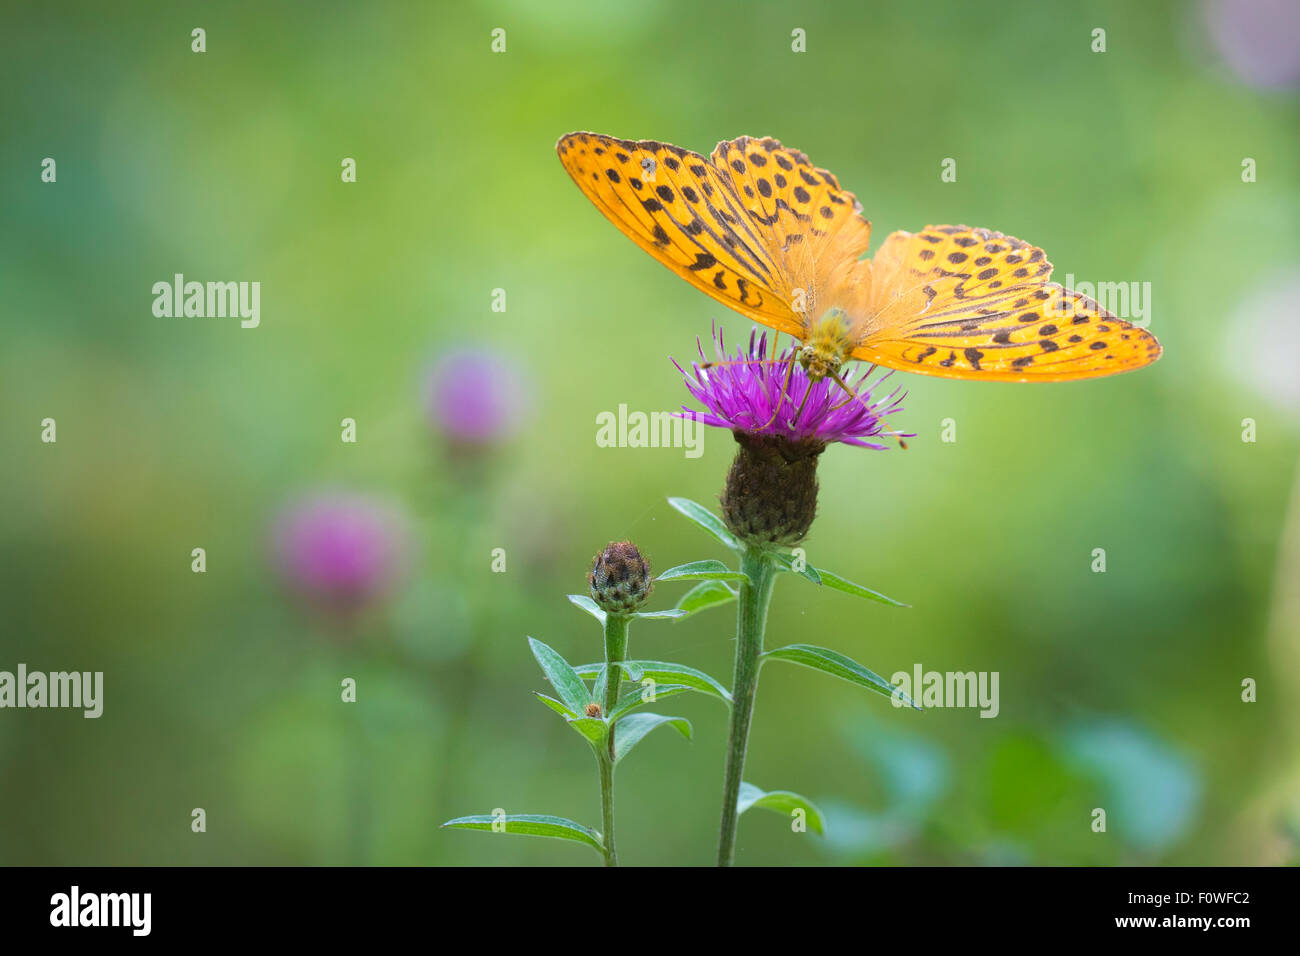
[722,432,826,546]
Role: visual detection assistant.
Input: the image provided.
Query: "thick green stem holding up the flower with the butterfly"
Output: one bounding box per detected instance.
[718,548,776,866]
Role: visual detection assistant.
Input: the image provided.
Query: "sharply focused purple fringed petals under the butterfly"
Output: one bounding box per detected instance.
[672,328,914,450]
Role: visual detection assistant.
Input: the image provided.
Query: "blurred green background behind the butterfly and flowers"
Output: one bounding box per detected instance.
[0,0,1300,865]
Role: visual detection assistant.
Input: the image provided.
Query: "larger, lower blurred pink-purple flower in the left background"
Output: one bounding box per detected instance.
[273,493,410,615]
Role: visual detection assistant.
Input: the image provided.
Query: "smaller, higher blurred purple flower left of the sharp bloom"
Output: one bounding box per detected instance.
[424,347,527,445]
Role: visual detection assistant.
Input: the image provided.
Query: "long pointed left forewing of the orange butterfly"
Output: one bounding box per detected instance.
[555,133,802,334]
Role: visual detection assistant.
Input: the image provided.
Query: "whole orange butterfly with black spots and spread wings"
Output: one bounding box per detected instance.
[555,133,1161,381]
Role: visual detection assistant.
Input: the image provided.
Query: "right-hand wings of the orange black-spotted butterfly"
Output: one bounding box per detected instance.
[852,226,1161,381]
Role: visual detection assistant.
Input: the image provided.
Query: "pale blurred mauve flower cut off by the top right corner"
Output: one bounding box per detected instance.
[1204,0,1300,90]
